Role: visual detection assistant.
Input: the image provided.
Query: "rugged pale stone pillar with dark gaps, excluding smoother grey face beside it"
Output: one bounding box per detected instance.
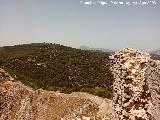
[110,48,151,120]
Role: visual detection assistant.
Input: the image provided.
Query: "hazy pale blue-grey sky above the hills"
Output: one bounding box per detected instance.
[0,0,160,50]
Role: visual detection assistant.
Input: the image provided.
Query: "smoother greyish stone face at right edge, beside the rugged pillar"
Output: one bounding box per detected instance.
[146,60,160,120]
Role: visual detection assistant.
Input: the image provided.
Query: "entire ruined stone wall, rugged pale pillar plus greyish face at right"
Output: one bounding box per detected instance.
[110,48,160,120]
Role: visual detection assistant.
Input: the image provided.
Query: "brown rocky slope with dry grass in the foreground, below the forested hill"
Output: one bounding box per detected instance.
[0,69,115,120]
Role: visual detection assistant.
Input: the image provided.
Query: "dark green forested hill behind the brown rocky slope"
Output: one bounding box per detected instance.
[0,43,113,98]
